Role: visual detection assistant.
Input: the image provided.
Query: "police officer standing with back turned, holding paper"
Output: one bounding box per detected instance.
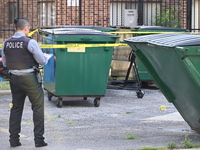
[2,18,47,147]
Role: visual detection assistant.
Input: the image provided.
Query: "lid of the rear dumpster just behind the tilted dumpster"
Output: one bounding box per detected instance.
[131,26,188,32]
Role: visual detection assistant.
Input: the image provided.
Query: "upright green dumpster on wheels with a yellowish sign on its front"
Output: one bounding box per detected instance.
[39,28,118,107]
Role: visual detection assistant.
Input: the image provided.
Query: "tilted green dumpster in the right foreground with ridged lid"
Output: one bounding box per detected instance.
[125,33,200,132]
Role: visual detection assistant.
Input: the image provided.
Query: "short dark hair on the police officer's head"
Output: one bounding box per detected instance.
[14,17,30,31]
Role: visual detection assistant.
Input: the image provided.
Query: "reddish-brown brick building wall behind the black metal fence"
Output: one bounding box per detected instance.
[0,0,186,38]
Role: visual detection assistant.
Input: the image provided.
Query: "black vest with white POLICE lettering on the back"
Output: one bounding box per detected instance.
[4,36,39,70]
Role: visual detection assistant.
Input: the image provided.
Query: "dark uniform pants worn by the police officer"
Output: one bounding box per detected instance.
[9,73,44,143]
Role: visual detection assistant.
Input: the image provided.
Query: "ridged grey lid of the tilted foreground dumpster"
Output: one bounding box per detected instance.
[124,33,200,47]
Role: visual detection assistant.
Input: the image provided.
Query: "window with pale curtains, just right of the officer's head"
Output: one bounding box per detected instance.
[39,2,55,26]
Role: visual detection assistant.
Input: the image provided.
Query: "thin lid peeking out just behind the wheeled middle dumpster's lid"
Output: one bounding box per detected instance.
[40,25,118,31]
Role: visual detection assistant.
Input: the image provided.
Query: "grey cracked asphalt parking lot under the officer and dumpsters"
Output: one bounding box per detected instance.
[0,90,200,150]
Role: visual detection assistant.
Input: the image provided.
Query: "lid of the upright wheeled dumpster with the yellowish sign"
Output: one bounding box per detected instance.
[39,28,118,37]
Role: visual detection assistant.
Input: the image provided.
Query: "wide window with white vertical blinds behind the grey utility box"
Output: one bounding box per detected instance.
[110,1,160,27]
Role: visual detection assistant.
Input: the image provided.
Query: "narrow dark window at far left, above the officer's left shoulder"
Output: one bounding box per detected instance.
[8,2,18,24]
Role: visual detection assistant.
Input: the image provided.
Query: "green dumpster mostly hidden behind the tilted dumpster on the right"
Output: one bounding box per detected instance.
[131,26,188,81]
